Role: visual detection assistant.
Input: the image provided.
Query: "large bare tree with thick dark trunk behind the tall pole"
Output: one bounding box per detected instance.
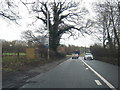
[26,0,92,52]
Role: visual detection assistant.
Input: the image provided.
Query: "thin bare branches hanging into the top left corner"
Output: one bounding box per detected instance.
[0,0,21,23]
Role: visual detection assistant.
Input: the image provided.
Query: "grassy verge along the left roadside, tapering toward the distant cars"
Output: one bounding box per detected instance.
[2,56,65,72]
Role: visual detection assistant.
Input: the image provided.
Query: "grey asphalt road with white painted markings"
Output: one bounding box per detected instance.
[21,57,118,89]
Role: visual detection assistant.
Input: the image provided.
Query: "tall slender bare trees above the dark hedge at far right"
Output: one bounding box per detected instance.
[96,1,119,48]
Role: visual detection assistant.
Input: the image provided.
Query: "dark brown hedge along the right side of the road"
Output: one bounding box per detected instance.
[90,44,118,64]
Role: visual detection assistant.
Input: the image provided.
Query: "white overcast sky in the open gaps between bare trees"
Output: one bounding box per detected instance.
[0,0,101,46]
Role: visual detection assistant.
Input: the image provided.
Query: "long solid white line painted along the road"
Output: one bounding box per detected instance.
[81,59,117,90]
